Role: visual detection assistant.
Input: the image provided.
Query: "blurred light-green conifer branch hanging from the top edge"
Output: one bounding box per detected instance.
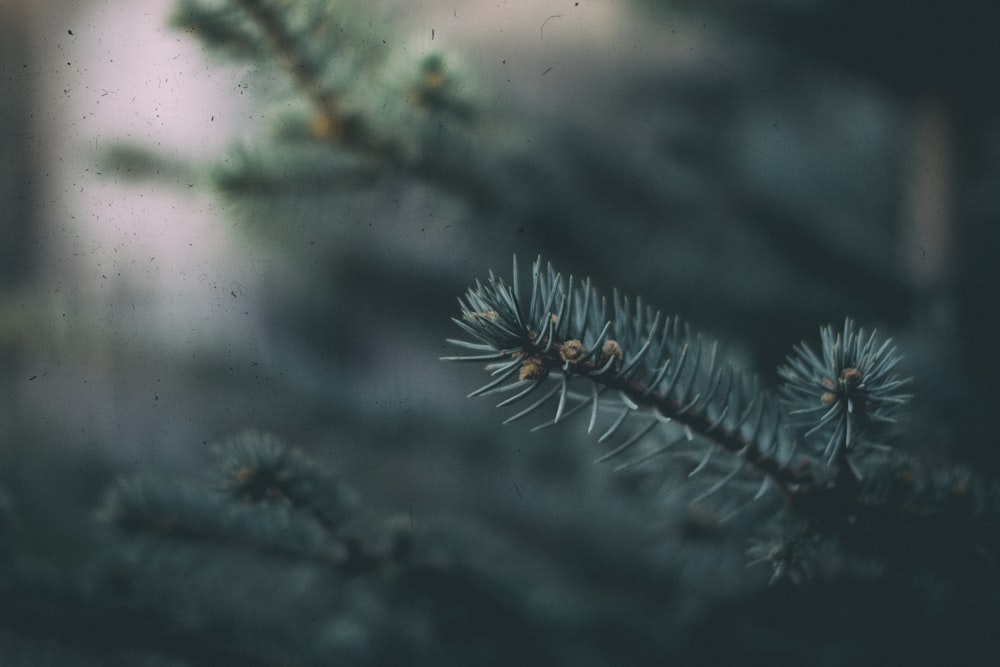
[168,0,480,197]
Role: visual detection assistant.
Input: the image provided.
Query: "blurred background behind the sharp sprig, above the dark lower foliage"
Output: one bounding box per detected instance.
[0,0,1000,664]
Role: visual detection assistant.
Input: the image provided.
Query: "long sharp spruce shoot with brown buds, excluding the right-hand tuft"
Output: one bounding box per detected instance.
[445,258,813,492]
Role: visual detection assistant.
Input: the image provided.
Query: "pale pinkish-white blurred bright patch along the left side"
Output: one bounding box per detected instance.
[7,0,260,464]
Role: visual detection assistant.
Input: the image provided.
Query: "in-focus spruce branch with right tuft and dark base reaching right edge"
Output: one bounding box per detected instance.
[444,258,1000,580]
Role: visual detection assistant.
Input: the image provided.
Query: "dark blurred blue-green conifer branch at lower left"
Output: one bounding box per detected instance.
[103,431,398,575]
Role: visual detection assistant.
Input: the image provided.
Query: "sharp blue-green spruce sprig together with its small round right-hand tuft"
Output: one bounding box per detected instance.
[444,257,910,512]
